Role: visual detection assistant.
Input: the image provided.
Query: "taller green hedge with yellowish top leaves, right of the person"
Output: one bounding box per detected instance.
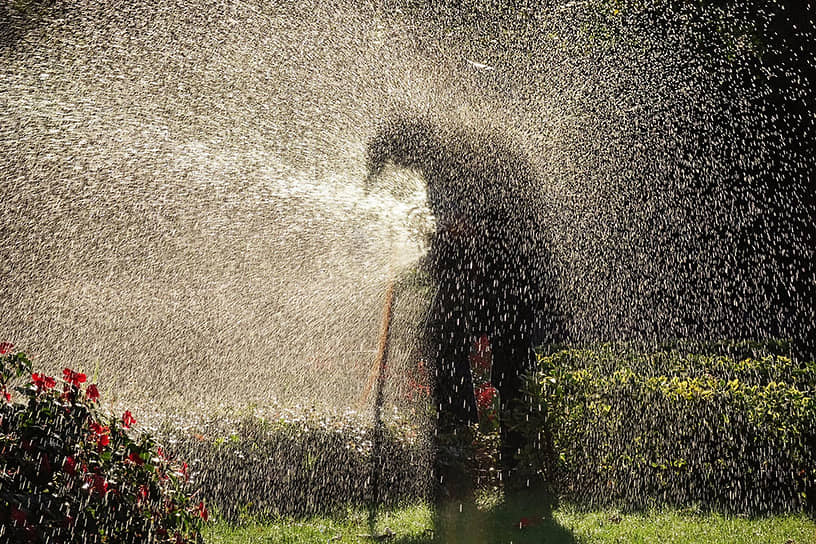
[513,344,816,514]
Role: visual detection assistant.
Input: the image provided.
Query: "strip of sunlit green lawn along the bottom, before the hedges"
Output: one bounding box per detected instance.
[204,498,816,544]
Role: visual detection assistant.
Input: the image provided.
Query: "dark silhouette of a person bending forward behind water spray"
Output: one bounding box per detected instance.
[366,115,563,482]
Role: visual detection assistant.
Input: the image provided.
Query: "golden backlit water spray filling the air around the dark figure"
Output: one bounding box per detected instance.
[0,0,816,520]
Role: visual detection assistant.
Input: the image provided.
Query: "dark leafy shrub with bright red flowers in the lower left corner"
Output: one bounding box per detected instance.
[0,343,208,544]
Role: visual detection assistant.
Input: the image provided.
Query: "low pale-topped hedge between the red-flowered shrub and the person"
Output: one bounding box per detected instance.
[155,405,430,521]
